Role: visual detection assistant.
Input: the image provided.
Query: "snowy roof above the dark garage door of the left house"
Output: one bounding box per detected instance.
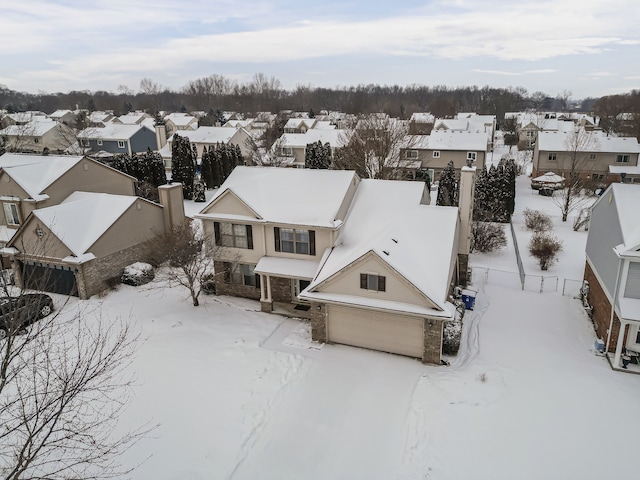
[32,192,144,257]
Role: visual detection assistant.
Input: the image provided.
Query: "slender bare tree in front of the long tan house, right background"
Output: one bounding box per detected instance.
[552,127,599,222]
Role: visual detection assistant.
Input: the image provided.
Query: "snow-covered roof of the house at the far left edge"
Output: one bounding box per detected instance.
[0,154,84,200]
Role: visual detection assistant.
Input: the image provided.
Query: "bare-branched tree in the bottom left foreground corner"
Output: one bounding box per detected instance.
[0,255,149,480]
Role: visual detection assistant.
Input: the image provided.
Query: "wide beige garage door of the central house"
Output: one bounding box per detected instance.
[327,305,424,358]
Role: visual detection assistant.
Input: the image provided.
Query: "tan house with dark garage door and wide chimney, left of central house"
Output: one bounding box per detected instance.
[2,184,185,299]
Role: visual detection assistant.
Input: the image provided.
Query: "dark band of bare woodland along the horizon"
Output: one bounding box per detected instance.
[0,73,596,119]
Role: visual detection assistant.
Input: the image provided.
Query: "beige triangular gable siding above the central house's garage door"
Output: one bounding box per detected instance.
[318,254,435,308]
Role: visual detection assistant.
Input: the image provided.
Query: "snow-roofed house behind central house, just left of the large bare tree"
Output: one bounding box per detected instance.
[272,129,350,168]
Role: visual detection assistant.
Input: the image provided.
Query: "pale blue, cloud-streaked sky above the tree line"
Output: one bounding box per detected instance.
[0,0,640,99]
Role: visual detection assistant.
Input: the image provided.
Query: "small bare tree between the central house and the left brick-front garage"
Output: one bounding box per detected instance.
[156,221,213,307]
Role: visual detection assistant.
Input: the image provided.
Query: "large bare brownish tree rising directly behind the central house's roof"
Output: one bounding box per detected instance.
[334,113,415,179]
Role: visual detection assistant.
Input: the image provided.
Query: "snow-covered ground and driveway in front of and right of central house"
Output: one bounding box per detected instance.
[51,170,640,480]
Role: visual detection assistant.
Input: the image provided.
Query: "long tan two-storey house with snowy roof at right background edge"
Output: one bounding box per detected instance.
[532,127,640,184]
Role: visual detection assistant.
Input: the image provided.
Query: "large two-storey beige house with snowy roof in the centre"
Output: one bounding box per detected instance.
[196,167,474,364]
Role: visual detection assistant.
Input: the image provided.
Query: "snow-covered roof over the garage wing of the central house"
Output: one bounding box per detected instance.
[305,179,458,310]
